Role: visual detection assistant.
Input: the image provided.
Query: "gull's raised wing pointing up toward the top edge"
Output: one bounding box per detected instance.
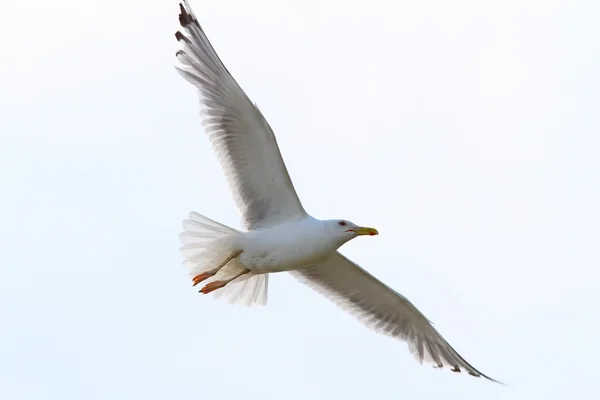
[175,1,306,229]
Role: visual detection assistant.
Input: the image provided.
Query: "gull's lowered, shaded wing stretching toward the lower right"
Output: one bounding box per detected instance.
[291,252,497,382]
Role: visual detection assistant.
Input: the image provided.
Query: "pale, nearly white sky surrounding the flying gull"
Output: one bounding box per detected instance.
[0,0,600,400]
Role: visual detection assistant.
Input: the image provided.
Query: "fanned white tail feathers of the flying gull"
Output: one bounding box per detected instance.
[179,211,269,306]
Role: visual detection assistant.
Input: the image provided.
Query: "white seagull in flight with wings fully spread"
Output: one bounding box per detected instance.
[175,1,497,382]
